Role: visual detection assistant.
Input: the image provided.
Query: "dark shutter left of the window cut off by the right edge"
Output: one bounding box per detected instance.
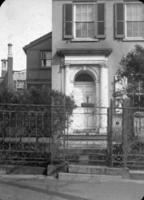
[114,3,124,38]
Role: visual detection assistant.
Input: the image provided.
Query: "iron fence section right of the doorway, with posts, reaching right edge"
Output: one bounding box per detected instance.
[108,100,144,169]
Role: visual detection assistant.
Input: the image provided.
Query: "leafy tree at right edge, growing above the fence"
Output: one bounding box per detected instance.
[114,45,144,106]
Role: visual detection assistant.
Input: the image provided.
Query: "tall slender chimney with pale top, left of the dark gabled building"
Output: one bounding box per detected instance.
[7,43,14,90]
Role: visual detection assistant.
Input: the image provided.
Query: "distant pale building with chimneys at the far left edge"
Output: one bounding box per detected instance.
[0,44,26,91]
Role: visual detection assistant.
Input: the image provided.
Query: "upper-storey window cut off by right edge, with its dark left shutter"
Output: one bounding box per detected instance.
[115,2,144,40]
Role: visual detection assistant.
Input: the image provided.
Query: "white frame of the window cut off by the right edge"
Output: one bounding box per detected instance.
[124,2,144,40]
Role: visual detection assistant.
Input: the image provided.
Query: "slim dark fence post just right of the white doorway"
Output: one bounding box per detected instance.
[107,100,113,167]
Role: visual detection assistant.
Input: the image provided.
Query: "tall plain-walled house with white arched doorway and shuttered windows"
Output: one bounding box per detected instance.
[52,0,144,138]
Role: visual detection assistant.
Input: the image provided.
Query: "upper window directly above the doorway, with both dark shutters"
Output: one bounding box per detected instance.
[63,3,105,39]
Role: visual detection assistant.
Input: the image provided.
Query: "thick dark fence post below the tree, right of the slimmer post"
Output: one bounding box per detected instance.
[122,99,130,168]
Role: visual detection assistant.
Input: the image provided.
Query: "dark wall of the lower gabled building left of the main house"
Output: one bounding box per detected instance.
[26,35,51,87]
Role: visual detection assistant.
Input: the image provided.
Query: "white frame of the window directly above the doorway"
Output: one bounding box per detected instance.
[73,2,97,41]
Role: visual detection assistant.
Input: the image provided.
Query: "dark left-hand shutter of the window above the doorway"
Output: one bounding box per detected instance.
[63,4,73,39]
